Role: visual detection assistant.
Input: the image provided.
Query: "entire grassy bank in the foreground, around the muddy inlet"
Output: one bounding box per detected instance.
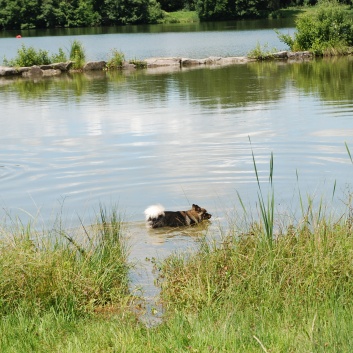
[0,187,353,352]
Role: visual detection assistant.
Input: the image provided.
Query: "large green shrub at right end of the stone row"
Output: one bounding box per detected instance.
[277,0,353,55]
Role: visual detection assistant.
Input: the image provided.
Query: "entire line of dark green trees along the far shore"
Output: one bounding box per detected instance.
[0,0,352,30]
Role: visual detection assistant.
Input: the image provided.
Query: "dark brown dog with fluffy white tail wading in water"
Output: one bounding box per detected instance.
[145,204,212,228]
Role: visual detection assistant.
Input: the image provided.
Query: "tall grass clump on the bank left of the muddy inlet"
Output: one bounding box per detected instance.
[0,208,129,316]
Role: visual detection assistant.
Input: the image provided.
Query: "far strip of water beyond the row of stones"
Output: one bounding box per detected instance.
[0,19,293,60]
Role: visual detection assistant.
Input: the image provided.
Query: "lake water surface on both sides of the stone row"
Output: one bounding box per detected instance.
[0,21,353,314]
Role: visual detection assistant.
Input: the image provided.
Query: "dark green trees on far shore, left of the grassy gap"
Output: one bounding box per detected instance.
[0,0,162,29]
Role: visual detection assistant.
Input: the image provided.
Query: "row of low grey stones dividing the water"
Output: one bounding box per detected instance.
[0,51,312,78]
